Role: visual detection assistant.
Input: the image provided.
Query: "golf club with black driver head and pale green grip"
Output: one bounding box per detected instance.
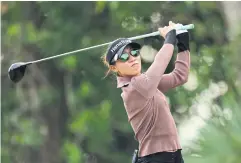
[8,24,194,83]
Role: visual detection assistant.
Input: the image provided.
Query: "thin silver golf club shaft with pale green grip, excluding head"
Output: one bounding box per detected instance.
[27,24,194,64]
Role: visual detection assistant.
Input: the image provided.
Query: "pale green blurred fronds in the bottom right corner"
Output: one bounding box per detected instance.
[185,108,241,163]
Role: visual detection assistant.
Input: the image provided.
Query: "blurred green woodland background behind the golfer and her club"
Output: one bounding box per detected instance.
[1,1,241,163]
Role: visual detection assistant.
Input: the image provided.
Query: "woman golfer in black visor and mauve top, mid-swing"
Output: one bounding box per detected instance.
[104,21,190,163]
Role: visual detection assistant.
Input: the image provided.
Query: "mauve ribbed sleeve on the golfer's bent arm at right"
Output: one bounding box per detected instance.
[158,50,190,92]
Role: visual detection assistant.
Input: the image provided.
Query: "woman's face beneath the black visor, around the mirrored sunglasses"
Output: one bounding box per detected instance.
[111,47,141,76]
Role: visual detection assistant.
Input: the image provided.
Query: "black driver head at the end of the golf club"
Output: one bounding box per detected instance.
[8,62,31,83]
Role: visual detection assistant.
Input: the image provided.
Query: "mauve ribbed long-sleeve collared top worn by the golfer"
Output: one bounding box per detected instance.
[117,44,190,157]
